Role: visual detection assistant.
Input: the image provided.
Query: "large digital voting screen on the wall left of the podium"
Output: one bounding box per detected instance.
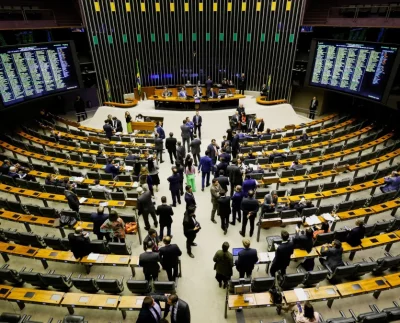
[0,42,80,107]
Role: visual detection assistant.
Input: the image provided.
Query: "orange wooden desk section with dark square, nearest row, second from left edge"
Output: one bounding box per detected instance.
[7,288,65,310]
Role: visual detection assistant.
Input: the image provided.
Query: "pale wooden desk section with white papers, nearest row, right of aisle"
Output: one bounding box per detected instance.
[283,285,340,308]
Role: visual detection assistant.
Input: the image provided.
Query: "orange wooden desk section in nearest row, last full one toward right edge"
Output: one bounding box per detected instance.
[336,277,390,298]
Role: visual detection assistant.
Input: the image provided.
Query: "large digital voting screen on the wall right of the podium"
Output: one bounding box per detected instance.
[308,40,398,102]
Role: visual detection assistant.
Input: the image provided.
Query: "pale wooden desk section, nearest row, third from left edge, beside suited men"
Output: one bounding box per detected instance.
[61,293,120,315]
